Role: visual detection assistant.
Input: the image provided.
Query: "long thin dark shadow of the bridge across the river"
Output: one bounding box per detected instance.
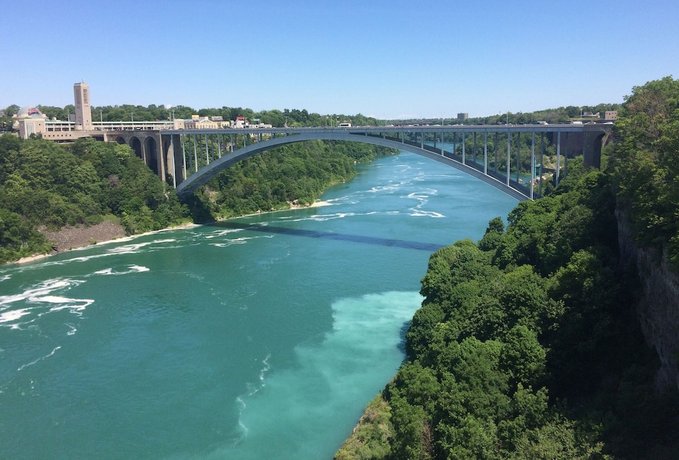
[208,221,444,252]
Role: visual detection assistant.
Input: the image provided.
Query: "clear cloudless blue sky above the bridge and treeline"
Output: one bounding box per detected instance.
[0,0,679,118]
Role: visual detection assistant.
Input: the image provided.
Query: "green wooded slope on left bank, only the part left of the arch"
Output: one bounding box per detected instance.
[0,134,189,262]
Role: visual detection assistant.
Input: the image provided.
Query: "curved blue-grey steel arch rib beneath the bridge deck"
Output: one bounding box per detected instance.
[177,130,530,200]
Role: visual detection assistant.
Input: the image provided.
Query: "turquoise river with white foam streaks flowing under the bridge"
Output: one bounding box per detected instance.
[0,153,516,460]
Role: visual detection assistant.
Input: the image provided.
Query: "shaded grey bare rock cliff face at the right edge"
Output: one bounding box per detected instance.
[616,211,679,391]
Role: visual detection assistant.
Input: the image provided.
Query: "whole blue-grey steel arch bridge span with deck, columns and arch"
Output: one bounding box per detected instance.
[160,124,612,200]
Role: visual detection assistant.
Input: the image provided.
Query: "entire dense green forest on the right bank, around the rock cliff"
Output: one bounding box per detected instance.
[337,77,679,459]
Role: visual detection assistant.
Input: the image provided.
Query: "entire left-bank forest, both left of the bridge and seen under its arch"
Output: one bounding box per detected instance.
[0,134,389,263]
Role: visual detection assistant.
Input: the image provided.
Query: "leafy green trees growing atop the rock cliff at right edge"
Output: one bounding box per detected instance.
[610,77,679,269]
